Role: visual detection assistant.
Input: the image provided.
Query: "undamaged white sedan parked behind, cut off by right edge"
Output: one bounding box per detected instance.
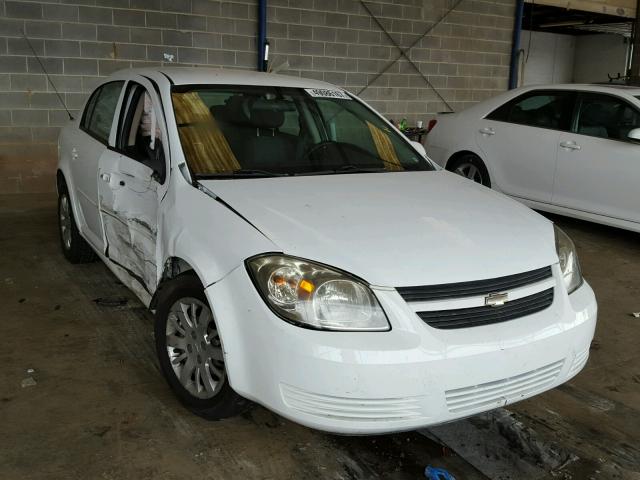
[426,85,640,232]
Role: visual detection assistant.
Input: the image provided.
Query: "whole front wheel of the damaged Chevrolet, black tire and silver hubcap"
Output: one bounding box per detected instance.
[155,272,250,420]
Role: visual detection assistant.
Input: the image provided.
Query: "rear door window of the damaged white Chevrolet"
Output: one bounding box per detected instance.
[81,81,124,143]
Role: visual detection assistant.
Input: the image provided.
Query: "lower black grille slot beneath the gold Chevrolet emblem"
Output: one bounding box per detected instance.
[418,288,553,329]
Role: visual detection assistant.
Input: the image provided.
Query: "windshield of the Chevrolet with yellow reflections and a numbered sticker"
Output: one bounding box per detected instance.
[171,85,433,178]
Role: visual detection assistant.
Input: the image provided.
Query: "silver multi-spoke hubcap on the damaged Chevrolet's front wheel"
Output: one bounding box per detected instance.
[166,298,226,399]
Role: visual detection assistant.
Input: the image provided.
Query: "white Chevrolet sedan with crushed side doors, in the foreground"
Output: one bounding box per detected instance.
[57,68,596,434]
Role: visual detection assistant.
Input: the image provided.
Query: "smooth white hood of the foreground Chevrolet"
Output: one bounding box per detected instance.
[202,171,558,287]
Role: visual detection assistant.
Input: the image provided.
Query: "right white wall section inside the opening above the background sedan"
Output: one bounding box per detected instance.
[573,34,628,83]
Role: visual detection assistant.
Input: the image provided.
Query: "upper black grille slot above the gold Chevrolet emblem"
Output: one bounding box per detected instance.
[396,267,551,302]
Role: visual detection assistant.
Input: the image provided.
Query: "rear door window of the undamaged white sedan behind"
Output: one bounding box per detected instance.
[486,90,575,131]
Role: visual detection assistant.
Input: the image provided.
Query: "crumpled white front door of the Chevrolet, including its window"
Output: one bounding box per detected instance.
[98,80,167,300]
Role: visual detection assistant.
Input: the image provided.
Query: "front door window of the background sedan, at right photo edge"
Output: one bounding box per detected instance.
[576,94,640,141]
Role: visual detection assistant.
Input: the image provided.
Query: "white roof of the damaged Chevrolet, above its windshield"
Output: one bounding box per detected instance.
[113,67,338,89]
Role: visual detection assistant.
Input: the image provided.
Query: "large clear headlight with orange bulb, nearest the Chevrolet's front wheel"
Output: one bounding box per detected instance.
[247,254,391,331]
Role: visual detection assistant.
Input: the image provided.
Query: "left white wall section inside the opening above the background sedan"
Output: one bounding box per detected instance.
[520,30,576,85]
